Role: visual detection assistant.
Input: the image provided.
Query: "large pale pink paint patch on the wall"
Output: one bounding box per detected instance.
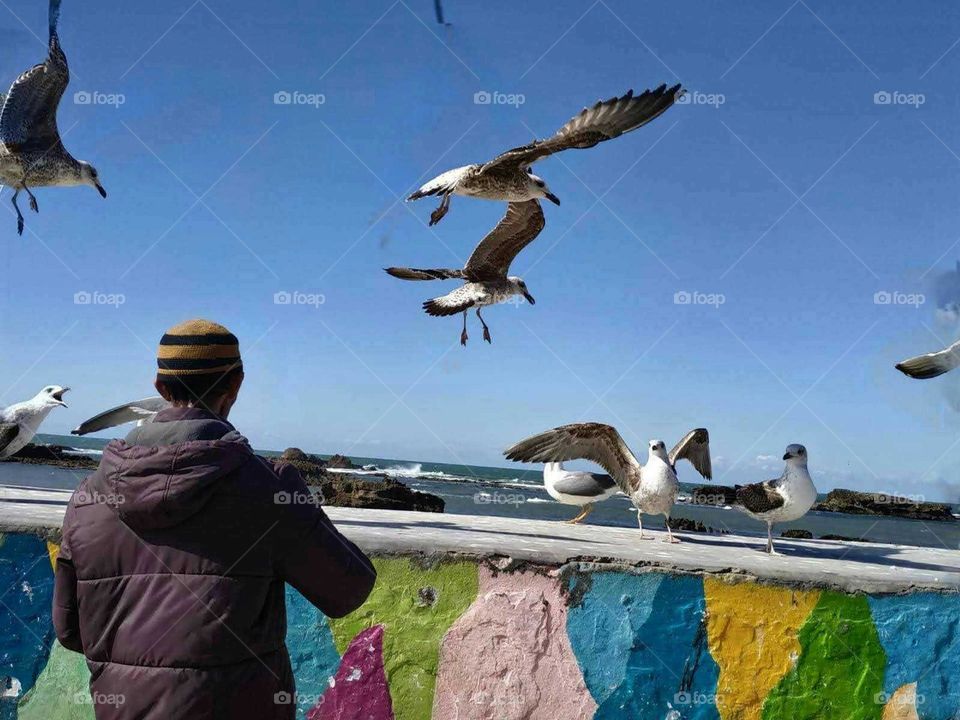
[433,567,597,720]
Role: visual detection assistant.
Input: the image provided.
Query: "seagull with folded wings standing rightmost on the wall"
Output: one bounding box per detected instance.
[736,445,817,555]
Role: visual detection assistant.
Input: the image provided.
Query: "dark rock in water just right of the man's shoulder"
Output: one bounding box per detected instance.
[281,448,444,512]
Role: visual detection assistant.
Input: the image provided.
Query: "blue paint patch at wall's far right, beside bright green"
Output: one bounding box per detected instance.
[868,593,960,720]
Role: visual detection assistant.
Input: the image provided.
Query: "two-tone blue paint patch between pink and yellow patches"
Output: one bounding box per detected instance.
[567,572,720,720]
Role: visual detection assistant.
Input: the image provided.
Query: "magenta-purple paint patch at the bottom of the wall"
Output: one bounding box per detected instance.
[307,625,393,720]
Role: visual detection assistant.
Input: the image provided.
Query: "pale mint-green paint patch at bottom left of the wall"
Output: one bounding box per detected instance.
[17,642,94,720]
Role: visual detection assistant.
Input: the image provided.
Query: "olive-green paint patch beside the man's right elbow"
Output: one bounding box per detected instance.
[330,558,479,720]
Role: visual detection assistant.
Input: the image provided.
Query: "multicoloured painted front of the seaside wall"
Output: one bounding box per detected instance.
[0,535,960,720]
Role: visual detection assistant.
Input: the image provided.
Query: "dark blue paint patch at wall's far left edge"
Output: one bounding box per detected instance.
[0,534,55,703]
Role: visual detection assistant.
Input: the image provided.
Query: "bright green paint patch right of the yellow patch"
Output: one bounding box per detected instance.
[762,592,886,720]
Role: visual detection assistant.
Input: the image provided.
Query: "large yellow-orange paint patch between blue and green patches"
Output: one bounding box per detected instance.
[703,578,820,720]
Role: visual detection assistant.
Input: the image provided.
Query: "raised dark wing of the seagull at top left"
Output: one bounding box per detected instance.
[0,0,70,151]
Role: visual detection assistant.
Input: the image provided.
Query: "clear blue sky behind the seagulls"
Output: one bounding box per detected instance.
[0,0,960,501]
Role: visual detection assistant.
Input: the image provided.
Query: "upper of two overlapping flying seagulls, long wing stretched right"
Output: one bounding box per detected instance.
[407,84,683,225]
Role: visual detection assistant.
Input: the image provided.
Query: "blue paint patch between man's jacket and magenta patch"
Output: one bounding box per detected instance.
[287,585,340,718]
